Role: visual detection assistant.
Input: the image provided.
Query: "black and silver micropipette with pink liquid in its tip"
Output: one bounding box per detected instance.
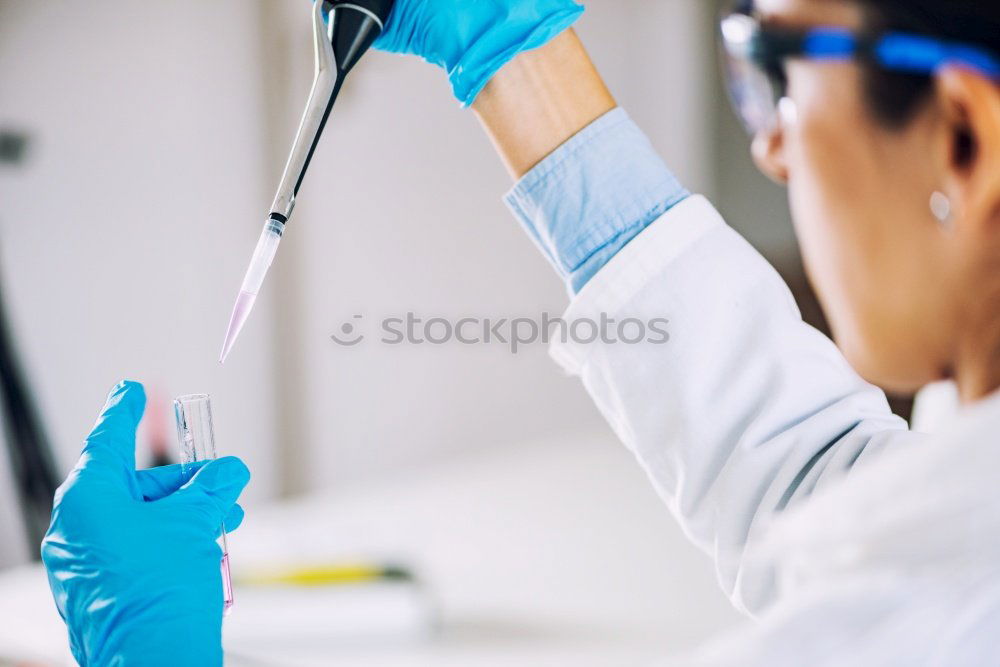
[219,0,393,363]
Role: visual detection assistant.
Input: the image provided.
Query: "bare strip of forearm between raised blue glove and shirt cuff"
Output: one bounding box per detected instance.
[472,29,615,178]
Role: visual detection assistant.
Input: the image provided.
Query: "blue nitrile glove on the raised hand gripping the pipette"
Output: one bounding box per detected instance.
[374,0,583,106]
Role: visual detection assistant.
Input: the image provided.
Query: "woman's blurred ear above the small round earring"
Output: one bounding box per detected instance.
[937,66,1000,232]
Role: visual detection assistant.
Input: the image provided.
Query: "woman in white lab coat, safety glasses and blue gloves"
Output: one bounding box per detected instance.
[43,0,1000,665]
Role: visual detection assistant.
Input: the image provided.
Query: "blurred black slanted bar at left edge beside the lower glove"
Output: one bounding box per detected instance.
[0,272,59,560]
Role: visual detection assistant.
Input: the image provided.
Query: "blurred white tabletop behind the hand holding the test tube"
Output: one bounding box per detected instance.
[0,436,739,667]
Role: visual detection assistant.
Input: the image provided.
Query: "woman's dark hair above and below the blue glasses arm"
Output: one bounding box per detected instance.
[855,0,1000,127]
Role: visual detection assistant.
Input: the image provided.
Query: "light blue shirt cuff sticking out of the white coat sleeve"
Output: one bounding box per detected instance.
[504,108,690,294]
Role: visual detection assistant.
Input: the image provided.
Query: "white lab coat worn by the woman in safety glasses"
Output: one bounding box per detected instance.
[552,197,1000,665]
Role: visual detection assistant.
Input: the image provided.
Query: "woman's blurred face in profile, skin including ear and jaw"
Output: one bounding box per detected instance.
[753,0,1000,392]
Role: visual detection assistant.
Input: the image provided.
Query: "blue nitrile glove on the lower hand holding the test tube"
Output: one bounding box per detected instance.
[42,382,250,666]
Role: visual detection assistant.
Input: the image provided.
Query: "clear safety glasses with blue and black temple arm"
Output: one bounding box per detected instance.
[719,12,1000,135]
